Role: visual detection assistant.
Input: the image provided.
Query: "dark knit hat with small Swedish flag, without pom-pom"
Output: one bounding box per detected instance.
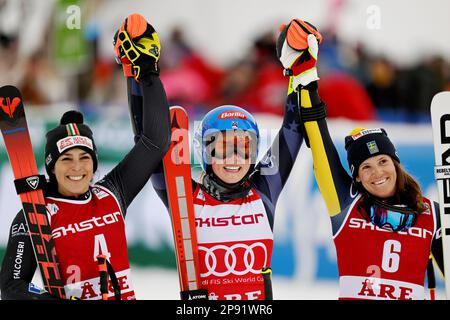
[345,128,400,179]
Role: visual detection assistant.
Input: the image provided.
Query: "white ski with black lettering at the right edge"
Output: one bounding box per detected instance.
[431,91,450,299]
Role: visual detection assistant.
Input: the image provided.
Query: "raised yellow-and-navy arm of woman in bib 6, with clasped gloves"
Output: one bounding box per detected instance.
[278,19,352,216]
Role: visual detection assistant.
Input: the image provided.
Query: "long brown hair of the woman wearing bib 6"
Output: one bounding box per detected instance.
[354,159,428,218]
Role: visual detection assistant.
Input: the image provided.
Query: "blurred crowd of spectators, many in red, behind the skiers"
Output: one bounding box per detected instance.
[0,1,450,123]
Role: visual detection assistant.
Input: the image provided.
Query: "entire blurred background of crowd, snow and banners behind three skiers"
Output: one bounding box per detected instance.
[0,0,450,299]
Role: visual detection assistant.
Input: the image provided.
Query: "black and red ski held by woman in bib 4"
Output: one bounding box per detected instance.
[0,86,64,298]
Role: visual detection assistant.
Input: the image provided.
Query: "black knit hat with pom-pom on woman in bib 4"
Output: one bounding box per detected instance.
[45,110,98,176]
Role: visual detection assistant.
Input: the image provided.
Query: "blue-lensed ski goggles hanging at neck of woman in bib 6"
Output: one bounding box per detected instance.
[369,199,417,231]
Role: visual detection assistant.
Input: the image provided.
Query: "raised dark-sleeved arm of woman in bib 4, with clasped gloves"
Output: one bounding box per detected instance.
[99,15,170,213]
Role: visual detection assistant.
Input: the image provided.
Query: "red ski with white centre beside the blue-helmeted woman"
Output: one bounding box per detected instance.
[163,106,207,300]
